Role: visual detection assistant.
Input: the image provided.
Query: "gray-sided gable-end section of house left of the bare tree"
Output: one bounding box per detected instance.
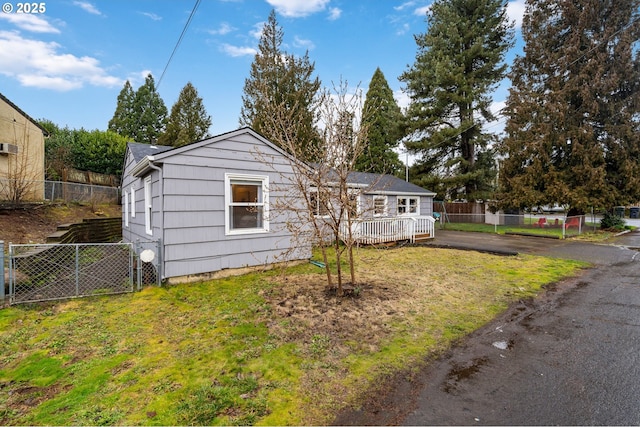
[122,128,311,281]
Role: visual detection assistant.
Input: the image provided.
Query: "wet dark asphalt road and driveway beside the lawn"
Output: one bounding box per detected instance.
[338,232,640,425]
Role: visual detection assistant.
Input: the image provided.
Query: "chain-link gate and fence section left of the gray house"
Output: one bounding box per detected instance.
[0,242,159,304]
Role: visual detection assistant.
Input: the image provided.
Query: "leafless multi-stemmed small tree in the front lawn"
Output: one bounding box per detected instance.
[255,78,380,296]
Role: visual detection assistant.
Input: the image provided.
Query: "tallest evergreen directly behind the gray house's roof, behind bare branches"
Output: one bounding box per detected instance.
[240,10,320,160]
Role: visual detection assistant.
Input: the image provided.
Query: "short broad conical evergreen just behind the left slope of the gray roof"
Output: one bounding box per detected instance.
[158,82,211,147]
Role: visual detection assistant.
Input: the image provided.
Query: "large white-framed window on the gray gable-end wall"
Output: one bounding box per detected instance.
[224,174,269,234]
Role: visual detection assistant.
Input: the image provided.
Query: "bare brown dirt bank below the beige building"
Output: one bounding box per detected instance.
[0,204,121,244]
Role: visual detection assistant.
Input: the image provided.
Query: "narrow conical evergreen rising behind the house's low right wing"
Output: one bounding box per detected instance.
[356,68,402,174]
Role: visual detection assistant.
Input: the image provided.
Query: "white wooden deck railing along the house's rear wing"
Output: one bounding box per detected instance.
[341,216,435,245]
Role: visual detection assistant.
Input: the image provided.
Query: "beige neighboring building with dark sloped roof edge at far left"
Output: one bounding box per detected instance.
[0,93,48,202]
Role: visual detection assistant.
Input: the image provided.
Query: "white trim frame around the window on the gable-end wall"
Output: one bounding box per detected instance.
[224,173,269,236]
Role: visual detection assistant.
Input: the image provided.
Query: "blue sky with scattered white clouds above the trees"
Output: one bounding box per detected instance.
[0,0,524,135]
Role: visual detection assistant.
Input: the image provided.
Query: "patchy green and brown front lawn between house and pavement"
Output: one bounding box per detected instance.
[0,247,584,425]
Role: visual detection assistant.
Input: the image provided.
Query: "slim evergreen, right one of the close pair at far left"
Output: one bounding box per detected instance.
[129,74,167,144]
